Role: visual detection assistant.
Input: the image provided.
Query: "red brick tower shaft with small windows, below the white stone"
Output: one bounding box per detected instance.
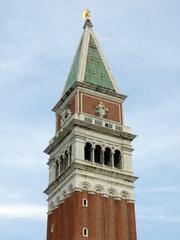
[47,192,136,240]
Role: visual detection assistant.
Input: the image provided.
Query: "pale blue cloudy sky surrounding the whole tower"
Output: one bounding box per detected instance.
[0,0,180,240]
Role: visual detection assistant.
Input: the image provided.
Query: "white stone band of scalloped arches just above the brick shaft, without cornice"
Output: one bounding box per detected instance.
[48,163,134,211]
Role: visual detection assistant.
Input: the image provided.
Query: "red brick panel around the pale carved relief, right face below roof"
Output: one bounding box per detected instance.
[80,93,122,123]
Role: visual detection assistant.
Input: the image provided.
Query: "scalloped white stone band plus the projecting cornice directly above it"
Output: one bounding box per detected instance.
[45,159,137,211]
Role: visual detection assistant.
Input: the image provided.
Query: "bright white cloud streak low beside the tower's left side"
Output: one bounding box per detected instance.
[0,205,47,219]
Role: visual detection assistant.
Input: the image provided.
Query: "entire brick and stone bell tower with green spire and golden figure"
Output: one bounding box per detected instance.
[45,12,137,240]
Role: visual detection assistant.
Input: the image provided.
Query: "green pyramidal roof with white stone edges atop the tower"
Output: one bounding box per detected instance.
[63,19,119,95]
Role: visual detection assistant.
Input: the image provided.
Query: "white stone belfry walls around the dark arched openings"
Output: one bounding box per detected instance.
[48,124,133,183]
